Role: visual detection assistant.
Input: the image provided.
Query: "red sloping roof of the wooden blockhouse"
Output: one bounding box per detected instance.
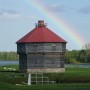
[16,21,66,43]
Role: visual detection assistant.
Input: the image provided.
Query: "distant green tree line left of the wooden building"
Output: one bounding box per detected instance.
[0,51,19,60]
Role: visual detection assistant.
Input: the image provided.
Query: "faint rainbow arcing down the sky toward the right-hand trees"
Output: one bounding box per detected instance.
[25,0,86,49]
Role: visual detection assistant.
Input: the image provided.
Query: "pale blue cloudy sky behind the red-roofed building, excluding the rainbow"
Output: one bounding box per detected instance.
[0,0,90,51]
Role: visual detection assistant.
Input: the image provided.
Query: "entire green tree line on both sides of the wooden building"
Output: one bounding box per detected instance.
[0,49,90,63]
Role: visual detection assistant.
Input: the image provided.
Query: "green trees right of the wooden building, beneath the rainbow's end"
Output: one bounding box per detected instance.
[65,49,90,63]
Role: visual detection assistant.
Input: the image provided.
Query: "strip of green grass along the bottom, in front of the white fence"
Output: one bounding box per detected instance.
[0,82,90,90]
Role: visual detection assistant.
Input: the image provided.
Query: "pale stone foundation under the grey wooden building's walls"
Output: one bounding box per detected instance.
[27,68,65,73]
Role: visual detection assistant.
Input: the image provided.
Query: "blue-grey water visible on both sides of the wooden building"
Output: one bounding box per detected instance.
[0,60,90,68]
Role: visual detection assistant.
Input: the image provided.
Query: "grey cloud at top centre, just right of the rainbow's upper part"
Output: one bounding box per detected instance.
[46,4,65,12]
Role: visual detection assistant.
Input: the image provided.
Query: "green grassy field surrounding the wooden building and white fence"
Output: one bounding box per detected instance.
[0,65,90,90]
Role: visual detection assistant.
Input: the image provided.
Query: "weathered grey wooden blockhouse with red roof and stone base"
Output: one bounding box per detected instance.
[16,20,67,73]
